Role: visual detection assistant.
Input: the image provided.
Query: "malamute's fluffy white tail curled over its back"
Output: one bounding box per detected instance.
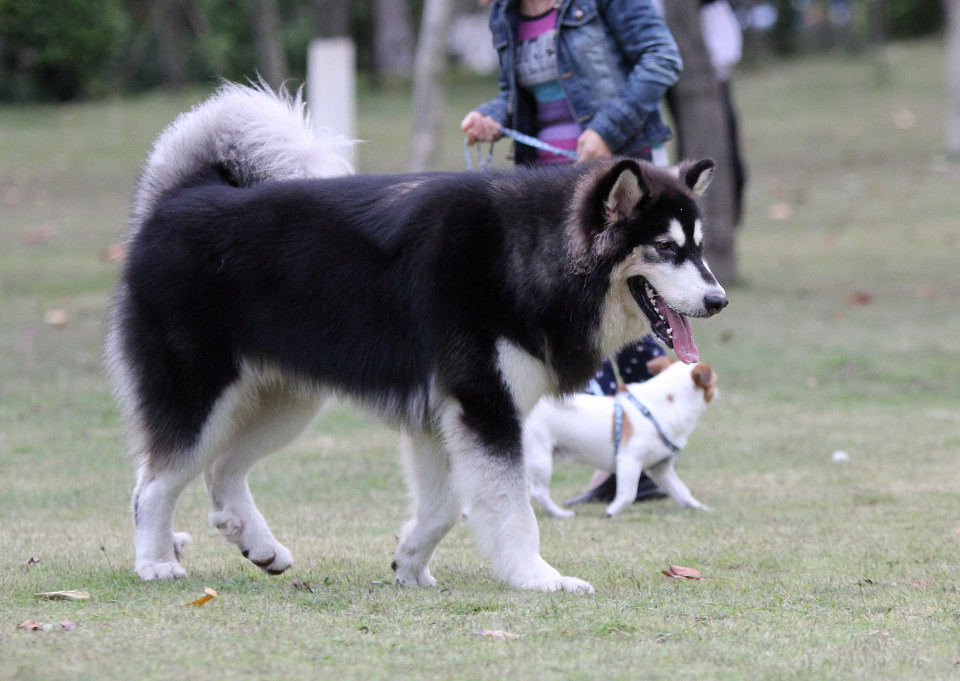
[128,80,353,238]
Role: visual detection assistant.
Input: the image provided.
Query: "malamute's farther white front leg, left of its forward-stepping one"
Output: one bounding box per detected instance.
[393,434,460,586]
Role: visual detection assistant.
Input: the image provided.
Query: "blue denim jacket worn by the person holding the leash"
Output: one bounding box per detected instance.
[476,0,683,164]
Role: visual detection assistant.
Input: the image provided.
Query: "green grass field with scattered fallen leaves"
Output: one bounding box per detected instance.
[0,38,960,681]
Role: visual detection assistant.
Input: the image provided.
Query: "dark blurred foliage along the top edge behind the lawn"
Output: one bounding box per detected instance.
[0,0,944,101]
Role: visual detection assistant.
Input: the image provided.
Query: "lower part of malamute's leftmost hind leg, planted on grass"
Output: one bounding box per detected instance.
[133,456,199,581]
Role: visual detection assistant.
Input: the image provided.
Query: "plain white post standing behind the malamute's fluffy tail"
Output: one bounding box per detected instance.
[307,38,357,161]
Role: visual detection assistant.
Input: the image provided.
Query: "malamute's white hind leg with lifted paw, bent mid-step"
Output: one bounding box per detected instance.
[203,387,320,575]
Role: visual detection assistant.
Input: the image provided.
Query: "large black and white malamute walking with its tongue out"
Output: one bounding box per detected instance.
[107,85,727,592]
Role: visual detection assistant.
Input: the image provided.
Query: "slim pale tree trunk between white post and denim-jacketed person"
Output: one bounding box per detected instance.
[407,0,453,172]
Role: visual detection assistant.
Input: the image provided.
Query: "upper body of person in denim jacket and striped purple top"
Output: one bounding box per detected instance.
[461,0,683,164]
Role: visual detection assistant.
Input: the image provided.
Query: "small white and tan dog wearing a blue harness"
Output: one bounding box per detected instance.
[523,357,719,518]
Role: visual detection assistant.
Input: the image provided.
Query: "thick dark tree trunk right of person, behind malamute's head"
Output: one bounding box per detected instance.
[664,0,738,284]
